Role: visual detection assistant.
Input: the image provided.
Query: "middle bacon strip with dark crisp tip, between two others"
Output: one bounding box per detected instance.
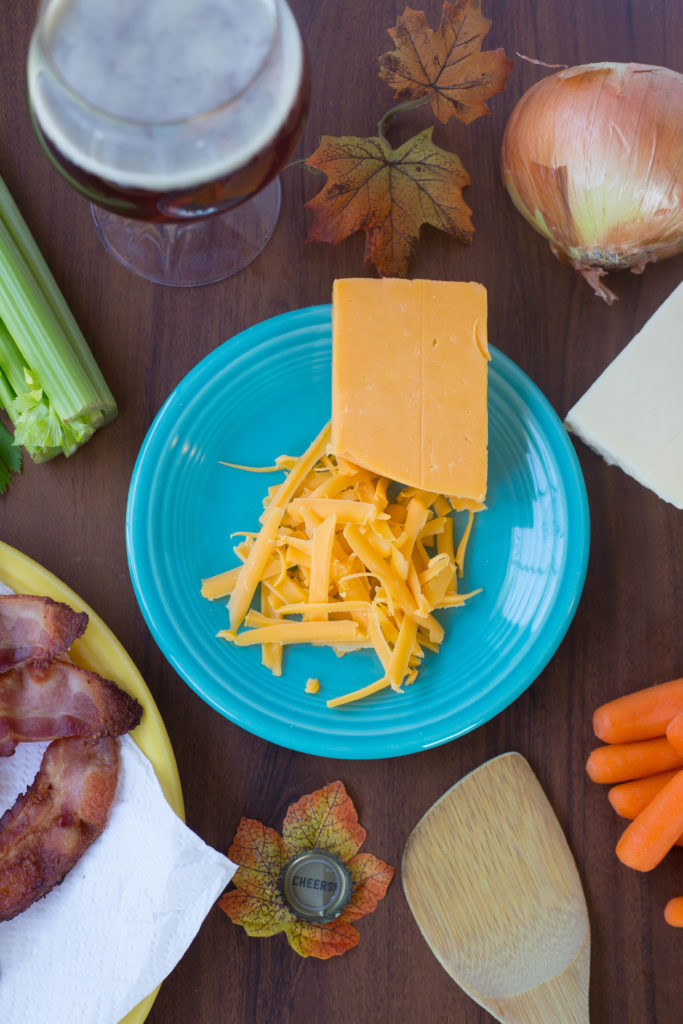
[0,657,142,758]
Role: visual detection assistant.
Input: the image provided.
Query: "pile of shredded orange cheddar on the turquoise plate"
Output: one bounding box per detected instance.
[202,424,479,708]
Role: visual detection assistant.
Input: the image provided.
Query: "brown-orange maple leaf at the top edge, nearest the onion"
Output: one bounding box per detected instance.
[380,0,513,124]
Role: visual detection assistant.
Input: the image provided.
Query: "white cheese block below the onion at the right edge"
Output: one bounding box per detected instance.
[565,284,683,509]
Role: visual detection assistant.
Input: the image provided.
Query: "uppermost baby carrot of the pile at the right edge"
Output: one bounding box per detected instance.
[593,678,683,743]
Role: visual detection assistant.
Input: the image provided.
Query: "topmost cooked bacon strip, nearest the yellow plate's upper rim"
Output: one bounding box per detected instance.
[0,594,88,672]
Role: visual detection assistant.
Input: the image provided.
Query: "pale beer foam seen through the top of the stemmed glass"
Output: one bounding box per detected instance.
[29,0,303,191]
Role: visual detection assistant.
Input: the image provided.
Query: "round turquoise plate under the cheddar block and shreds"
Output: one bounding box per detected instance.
[126,305,589,758]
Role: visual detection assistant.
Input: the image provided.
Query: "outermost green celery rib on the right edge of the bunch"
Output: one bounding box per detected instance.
[0,176,117,426]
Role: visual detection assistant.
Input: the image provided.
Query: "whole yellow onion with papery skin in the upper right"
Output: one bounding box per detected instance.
[502,63,683,303]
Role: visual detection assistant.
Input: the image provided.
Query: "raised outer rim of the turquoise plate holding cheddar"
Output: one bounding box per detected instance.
[125,303,590,760]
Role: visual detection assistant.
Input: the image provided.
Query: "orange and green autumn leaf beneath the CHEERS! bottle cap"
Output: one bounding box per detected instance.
[218,782,394,959]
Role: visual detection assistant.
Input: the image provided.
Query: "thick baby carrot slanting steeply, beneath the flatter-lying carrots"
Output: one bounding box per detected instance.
[616,771,683,871]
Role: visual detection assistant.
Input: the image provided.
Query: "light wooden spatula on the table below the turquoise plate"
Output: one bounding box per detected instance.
[401,754,591,1024]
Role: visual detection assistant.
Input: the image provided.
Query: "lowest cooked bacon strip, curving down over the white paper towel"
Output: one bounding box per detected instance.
[0,736,119,921]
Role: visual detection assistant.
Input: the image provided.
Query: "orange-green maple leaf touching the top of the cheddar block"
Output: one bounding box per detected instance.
[306,128,474,276]
